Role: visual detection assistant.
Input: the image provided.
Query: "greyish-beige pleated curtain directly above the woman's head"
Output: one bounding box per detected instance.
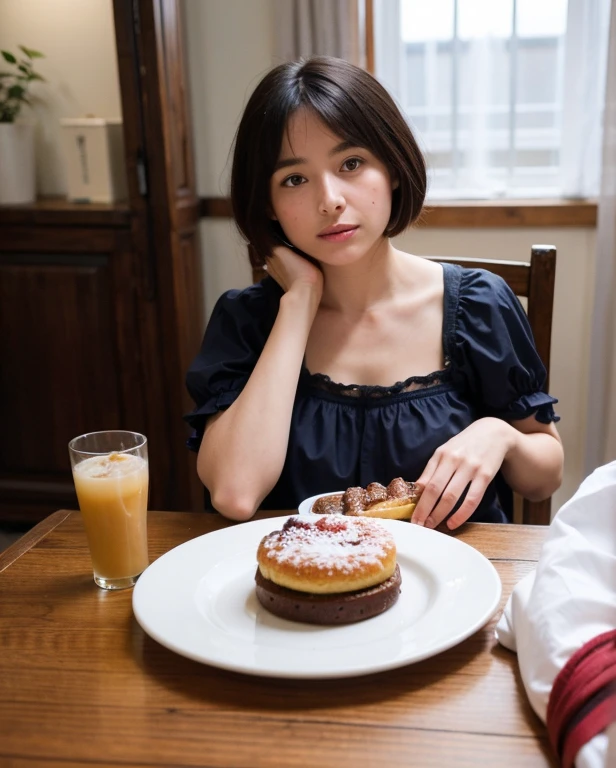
[274,0,364,66]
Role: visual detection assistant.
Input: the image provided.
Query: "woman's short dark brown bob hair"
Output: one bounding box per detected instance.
[231,56,426,267]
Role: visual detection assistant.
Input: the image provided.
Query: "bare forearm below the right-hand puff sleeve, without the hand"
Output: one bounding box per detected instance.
[501,425,564,501]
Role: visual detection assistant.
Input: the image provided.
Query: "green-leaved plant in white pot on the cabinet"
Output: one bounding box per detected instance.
[0,45,44,204]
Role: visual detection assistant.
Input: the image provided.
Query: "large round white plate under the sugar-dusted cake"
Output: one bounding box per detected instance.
[133,517,501,678]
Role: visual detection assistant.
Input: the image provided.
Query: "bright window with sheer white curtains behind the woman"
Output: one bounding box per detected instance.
[374,0,609,199]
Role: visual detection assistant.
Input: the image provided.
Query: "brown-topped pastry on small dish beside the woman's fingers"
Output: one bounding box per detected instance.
[311,477,420,520]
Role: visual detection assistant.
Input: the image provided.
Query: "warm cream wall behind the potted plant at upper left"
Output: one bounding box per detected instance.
[0,0,122,195]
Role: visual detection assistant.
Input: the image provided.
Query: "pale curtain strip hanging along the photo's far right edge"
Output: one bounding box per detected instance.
[585,4,616,474]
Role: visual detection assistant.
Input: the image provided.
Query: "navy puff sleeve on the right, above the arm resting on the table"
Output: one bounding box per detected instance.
[450,269,559,424]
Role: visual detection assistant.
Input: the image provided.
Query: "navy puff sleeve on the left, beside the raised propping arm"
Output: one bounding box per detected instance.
[184,278,281,451]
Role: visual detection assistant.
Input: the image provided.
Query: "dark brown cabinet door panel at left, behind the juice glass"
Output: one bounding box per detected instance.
[0,227,144,522]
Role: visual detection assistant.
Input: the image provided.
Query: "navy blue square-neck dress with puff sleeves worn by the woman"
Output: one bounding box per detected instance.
[185,264,558,522]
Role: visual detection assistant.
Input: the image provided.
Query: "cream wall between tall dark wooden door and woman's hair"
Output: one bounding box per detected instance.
[183,0,274,314]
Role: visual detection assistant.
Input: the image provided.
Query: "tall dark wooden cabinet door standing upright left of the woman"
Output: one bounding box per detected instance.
[113,0,204,510]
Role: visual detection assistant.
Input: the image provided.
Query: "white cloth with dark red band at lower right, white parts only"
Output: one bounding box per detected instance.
[496,461,616,768]
